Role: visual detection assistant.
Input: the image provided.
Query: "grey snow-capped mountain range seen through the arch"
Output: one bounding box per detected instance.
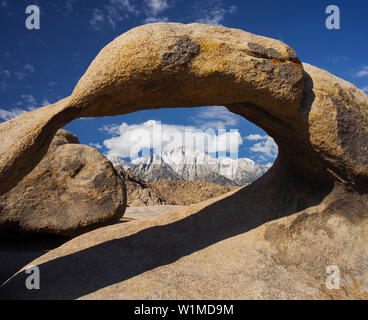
[109,147,270,185]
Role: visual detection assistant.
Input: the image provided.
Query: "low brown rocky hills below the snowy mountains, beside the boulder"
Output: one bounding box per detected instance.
[115,165,238,207]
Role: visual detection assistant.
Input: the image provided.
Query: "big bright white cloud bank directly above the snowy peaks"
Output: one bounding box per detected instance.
[102,120,243,159]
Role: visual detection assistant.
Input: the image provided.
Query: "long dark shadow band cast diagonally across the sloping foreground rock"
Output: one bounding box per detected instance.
[0,158,331,299]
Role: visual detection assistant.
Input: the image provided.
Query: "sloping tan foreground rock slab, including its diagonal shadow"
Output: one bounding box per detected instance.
[0,177,368,299]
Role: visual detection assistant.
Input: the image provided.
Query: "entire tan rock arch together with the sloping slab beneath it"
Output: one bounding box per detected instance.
[0,23,368,299]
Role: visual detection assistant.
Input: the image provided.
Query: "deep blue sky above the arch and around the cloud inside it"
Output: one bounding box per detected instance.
[0,0,368,163]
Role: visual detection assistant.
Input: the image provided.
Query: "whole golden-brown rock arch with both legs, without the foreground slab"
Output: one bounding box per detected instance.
[0,23,368,216]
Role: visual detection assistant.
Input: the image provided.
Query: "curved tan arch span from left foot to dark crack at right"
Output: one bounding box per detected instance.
[0,23,304,194]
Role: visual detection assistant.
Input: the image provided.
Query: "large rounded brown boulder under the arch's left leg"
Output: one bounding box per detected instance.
[0,130,126,236]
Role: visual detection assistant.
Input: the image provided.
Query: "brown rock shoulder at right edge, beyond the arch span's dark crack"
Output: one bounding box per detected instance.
[301,64,368,193]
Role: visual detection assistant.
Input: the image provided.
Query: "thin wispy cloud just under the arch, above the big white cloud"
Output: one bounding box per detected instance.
[193,106,240,129]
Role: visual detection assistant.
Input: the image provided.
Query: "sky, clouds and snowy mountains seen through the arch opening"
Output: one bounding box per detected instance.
[64,106,278,198]
